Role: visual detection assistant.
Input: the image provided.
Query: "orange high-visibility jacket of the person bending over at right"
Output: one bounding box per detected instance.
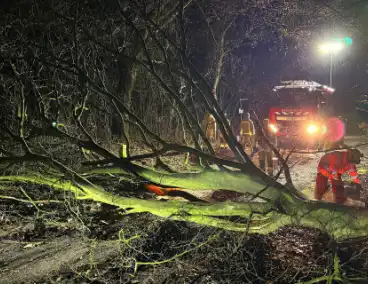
[318,151,360,184]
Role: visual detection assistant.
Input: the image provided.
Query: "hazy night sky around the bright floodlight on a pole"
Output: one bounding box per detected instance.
[188,1,368,121]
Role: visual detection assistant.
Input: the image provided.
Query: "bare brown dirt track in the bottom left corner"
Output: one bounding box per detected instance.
[0,237,118,284]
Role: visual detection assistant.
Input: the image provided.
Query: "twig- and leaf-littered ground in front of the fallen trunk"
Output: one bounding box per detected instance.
[0,203,368,283]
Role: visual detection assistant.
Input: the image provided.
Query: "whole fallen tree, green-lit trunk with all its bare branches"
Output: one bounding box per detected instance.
[0,1,368,251]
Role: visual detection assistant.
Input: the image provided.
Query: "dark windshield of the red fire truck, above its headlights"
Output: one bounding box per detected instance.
[274,89,318,107]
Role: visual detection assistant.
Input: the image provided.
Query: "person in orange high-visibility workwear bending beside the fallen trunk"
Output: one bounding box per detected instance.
[314,149,363,204]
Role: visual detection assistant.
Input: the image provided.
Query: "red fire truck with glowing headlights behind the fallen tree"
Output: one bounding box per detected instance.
[269,80,335,148]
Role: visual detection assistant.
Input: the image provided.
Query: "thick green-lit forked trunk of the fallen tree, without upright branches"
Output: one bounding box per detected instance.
[0,144,368,240]
